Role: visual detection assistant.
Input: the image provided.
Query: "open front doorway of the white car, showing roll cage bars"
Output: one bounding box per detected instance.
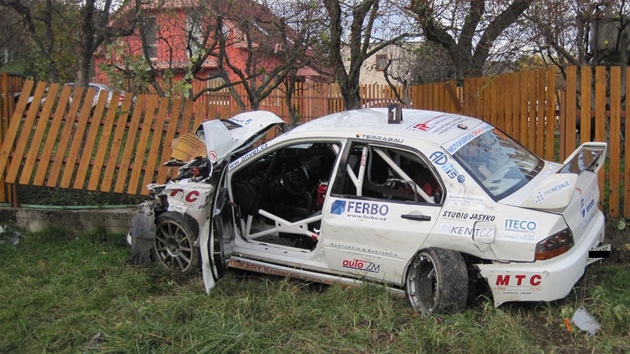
[231,143,339,250]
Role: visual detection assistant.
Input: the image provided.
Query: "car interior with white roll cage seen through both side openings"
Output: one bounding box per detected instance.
[230,143,442,250]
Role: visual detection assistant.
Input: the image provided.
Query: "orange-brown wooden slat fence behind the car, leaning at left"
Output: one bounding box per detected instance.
[0,67,630,217]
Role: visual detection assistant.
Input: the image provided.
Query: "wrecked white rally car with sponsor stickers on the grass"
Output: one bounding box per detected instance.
[129,106,610,316]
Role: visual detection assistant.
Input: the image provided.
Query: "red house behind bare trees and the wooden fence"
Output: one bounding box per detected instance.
[96,0,322,92]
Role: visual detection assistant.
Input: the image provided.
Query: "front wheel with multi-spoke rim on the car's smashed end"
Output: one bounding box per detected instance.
[152,211,200,274]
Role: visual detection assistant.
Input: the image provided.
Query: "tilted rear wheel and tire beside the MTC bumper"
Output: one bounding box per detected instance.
[405,248,468,317]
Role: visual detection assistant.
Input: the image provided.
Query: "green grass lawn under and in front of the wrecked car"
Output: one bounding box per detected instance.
[0,229,630,353]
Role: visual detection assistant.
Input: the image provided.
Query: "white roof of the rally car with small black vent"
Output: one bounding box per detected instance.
[285,108,483,145]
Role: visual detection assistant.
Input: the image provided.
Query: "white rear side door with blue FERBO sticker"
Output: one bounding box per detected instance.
[322,140,444,284]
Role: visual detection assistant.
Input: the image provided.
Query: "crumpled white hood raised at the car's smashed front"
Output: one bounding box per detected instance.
[197,111,286,163]
